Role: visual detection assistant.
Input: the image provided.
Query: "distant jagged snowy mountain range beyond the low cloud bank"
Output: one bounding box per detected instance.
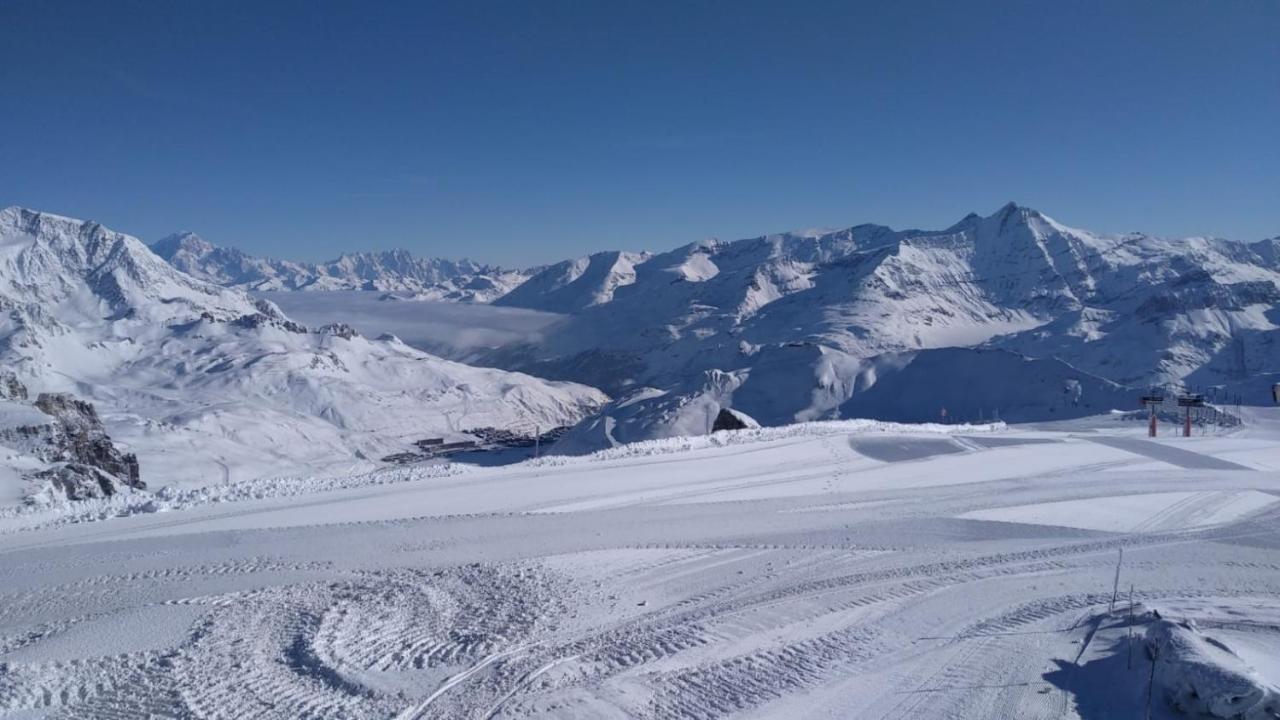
[151,232,529,302]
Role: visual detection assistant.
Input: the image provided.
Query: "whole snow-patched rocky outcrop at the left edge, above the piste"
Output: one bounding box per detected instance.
[0,373,146,500]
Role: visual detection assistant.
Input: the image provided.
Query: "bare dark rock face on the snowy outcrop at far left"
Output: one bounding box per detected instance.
[36,393,146,489]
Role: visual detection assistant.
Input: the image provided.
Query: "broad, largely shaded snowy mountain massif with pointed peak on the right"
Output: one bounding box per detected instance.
[489,204,1280,448]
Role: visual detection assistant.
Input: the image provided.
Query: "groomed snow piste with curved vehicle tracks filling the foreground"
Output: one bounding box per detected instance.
[0,411,1280,720]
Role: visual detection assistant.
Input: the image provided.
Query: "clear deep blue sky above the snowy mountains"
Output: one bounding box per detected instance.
[0,0,1280,265]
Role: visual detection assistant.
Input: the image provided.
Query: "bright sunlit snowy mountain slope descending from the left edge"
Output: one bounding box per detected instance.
[0,208,607,499]
